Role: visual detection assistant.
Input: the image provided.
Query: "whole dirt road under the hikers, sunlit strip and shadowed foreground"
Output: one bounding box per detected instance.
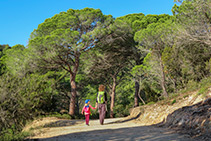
[30,118,193,141]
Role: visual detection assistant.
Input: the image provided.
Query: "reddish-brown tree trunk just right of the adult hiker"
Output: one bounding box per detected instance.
[110,76,117,118]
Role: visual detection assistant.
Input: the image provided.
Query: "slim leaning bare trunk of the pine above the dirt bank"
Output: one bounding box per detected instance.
[158,53,168,97]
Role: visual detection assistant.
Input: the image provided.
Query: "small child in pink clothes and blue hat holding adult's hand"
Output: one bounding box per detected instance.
[81,99,96,126]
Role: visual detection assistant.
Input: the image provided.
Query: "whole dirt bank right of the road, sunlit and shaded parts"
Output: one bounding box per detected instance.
[130,89,211,140]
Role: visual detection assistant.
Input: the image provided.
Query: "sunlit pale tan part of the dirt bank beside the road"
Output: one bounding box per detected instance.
[130,89,211,125]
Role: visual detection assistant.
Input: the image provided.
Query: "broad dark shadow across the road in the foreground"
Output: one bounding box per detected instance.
[28,126,193,141]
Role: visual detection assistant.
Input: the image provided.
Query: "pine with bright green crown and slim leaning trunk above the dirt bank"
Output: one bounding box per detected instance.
[135,16,173,97]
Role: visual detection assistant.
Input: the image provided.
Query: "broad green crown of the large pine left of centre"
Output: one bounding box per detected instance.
[29,8,113,73]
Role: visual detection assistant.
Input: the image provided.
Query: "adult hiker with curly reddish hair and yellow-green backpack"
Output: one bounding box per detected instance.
[95,85,107,125]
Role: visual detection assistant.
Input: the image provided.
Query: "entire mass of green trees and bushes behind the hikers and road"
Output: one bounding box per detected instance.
[0,0,211,140]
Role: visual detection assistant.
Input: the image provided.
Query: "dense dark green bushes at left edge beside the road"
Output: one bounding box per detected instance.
[0,71,60,139]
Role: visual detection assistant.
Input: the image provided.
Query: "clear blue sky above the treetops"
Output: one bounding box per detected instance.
[0,0,174,46]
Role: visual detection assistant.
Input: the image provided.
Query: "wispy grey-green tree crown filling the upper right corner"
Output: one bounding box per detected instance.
[172,0,211,49]
